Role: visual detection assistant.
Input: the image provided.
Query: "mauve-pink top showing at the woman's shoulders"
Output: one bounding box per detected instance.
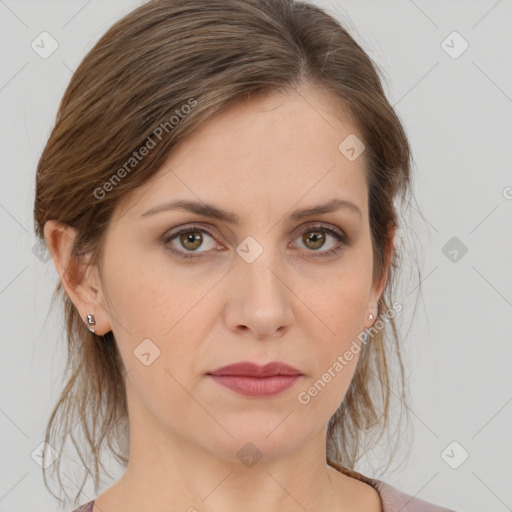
[71,478,455,512]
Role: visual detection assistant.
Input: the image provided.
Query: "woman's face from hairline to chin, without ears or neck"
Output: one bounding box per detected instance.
[91,88,380,460]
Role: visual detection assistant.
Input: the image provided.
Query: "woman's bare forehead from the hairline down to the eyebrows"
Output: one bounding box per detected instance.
[115,88,367,223]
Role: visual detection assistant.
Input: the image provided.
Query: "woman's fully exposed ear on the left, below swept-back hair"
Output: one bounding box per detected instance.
[44,220,111,336]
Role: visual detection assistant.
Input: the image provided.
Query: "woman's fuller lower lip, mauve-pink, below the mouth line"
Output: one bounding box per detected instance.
[210,375,302,396]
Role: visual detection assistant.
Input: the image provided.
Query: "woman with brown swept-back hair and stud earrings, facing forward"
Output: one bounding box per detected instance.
[34,0,456,512]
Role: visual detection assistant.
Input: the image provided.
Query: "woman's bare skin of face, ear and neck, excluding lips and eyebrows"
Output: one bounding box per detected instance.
[45,86,389,512]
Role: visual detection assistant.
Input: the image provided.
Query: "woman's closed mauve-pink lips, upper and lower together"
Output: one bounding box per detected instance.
[208,362,303,397]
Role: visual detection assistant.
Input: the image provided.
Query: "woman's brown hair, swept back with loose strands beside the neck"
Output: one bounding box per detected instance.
[34,0,422,503]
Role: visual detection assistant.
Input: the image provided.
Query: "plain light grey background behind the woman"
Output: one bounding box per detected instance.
[0,0,512,512]
